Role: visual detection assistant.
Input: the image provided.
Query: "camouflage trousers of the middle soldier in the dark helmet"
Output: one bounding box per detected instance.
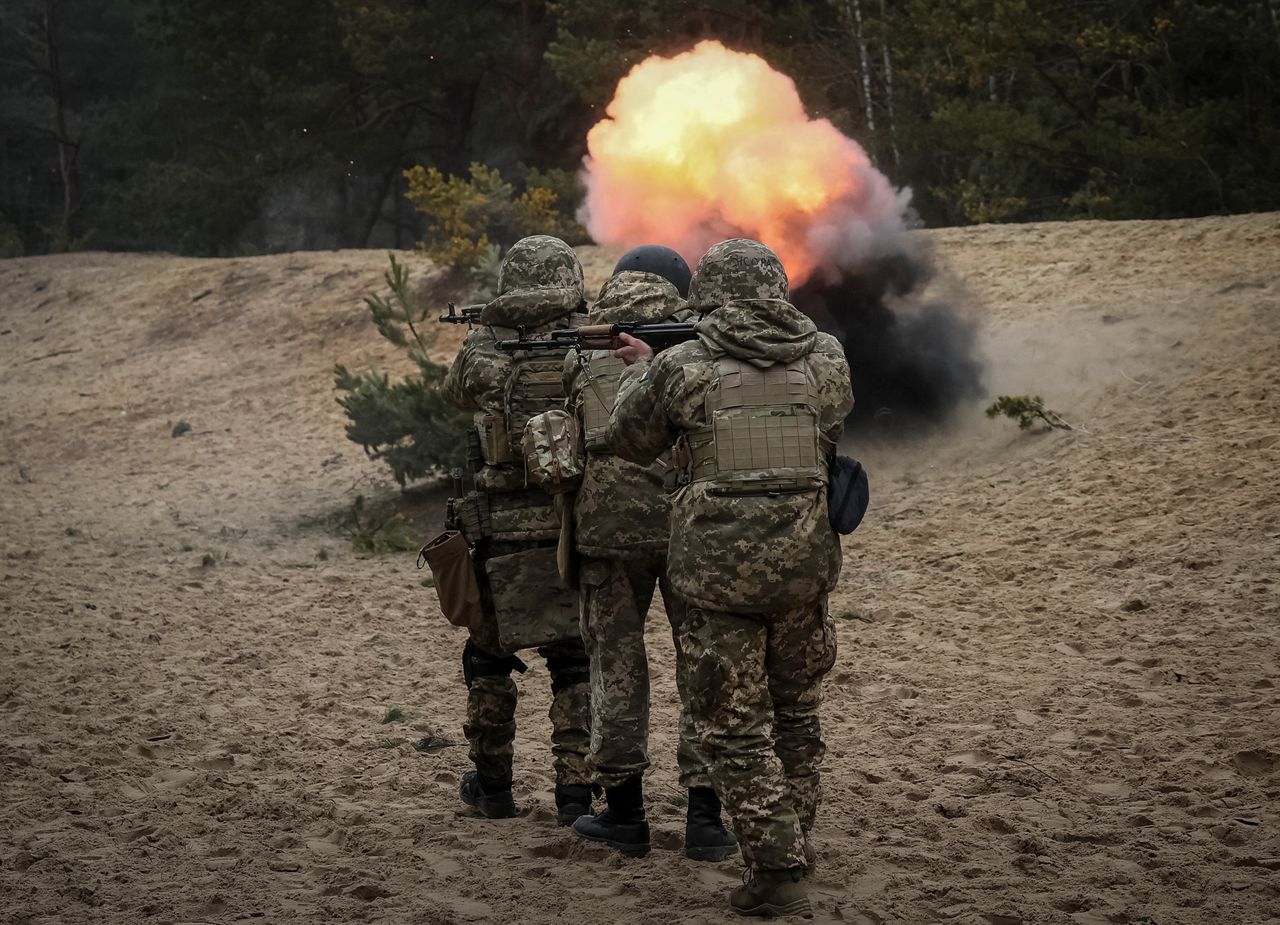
[580,553,712,788]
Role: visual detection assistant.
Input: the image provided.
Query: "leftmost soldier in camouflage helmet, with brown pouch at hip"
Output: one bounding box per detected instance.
[442,235,591,825]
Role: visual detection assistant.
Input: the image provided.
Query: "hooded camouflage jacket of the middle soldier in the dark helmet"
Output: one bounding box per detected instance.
[564,271,690,559]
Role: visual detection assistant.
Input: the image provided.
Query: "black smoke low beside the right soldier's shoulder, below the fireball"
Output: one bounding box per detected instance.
[791,245,984,436]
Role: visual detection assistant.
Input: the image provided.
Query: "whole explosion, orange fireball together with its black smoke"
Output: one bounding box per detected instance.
[579,41,982,432]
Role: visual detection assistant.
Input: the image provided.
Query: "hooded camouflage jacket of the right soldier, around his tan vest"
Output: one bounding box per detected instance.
[608,298,854,613]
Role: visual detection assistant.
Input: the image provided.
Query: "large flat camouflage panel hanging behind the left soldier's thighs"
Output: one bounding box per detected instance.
[484,546,580,654]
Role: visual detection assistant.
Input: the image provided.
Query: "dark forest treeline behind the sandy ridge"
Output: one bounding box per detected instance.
[0,0,1280,256]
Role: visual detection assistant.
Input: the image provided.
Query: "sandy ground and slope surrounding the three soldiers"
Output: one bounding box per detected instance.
[0,215,1280,925]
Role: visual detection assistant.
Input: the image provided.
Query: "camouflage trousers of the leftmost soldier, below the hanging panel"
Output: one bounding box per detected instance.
[462,534,591,784]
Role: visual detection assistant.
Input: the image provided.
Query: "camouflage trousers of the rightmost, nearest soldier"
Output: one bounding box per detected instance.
[680,599,836,870]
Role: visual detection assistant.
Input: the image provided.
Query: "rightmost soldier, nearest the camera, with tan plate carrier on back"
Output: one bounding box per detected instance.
[608,238,854,916]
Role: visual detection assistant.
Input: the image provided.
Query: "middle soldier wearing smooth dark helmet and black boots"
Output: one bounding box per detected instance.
[564,244,737,861]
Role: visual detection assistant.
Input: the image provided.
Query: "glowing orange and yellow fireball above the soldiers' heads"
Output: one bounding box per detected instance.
[580,41,909,285]
